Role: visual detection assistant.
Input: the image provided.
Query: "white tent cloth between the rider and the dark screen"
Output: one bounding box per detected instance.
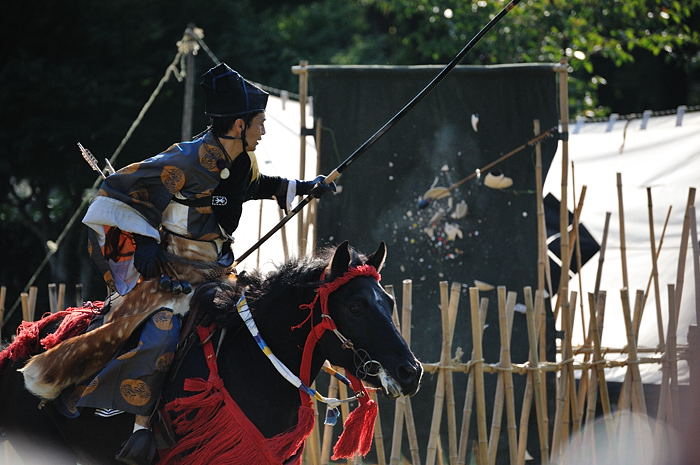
[233,95,317,271]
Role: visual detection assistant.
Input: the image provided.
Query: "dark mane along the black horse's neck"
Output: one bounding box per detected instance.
[192,247,367,327]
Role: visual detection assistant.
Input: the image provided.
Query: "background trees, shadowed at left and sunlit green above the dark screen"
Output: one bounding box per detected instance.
[0,0,700,330]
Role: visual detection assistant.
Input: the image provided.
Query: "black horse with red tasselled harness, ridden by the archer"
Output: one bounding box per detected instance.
[0,242,423,464]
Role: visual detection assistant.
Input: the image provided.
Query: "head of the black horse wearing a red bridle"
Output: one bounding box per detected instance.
[321,241,423,397]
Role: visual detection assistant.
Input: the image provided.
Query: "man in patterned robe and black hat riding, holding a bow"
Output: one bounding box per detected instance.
[17,64,335,463]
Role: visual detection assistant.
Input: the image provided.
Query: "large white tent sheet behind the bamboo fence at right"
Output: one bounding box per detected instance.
[544,113,700,383]
